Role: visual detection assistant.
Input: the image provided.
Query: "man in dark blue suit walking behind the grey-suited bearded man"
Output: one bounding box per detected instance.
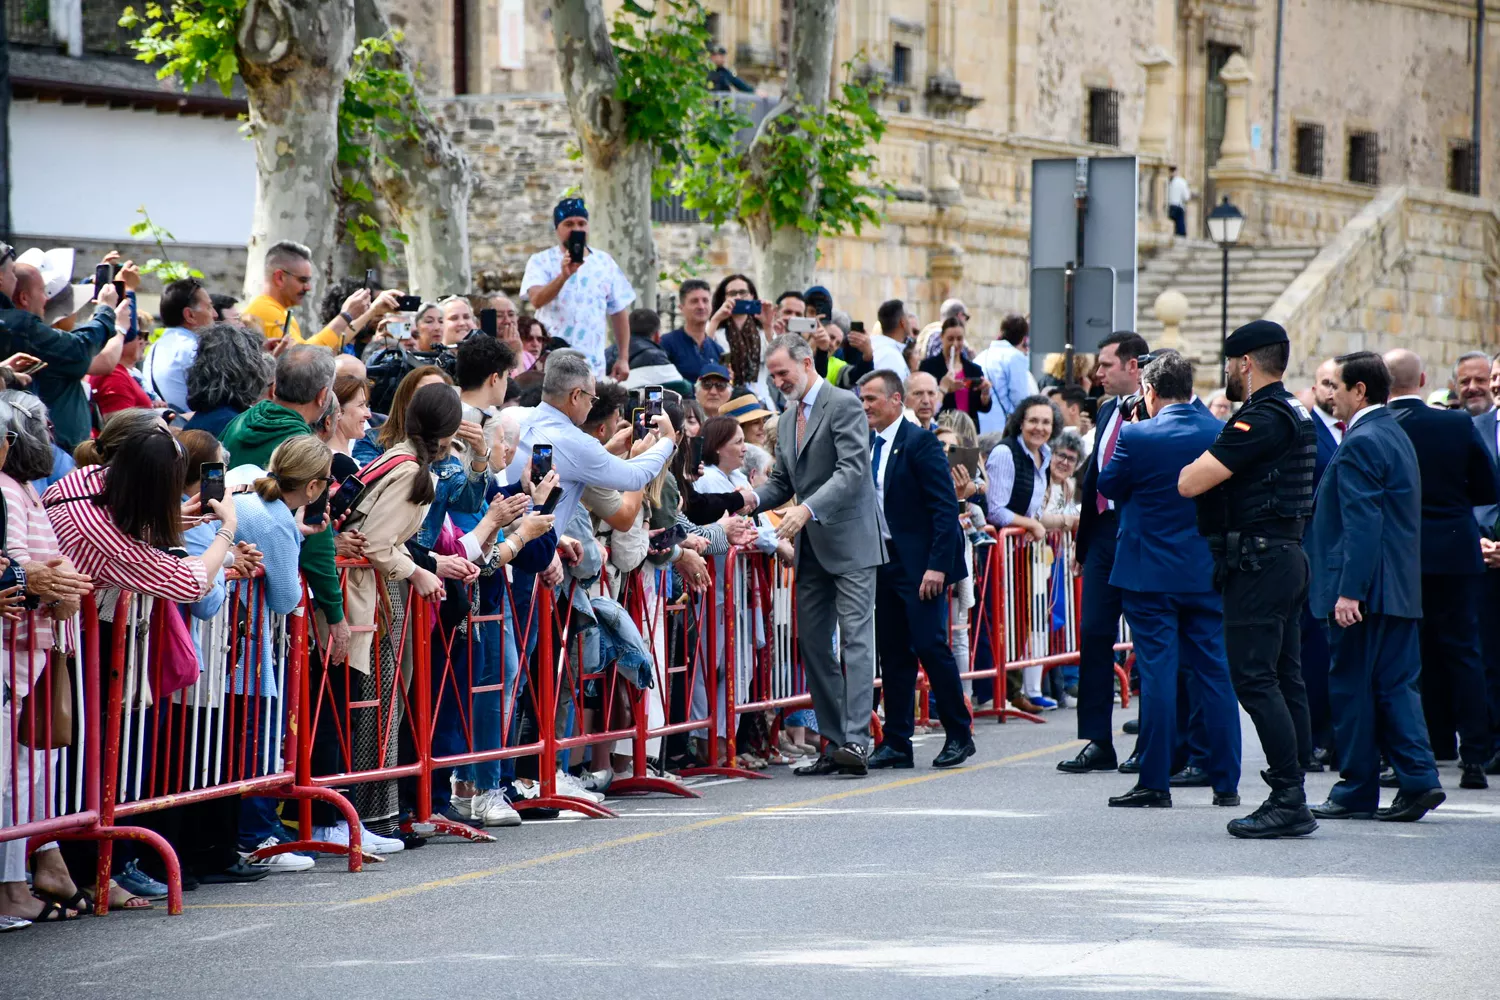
[860,370,974,769]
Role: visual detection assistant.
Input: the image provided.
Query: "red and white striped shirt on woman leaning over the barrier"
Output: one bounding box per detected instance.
[42,465,210,610]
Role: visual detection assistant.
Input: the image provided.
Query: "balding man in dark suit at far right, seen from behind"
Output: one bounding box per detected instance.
[1386,349,1496,789]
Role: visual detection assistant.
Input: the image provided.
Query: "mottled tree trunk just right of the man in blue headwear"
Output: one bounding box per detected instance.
[552,0,657,309]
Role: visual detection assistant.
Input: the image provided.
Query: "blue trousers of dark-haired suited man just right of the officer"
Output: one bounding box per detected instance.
[1328,613,1439,813]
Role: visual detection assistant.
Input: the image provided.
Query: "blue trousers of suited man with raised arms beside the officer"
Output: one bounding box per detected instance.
[1124,591,1241,792]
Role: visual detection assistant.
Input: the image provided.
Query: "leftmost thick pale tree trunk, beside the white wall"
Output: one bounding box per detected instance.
[239,0,354,310]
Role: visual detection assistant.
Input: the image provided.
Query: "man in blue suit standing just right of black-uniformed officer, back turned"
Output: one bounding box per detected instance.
[1307,351,1445,822]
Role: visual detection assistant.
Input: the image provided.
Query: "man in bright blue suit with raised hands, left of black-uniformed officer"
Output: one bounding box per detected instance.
[1098,352,1241,807]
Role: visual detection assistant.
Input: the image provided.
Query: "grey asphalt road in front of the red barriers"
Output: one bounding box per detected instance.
[0,712,1500,1000]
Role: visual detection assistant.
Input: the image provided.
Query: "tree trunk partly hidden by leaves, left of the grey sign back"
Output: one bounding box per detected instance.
[744,0,839,297]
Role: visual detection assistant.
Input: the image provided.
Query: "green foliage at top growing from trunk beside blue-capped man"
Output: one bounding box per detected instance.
[609,0,750,198]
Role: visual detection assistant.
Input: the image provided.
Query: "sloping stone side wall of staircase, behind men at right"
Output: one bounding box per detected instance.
[1266,187,1500,381]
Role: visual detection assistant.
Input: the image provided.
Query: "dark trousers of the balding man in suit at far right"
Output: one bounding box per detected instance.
[1419,573,1496,765]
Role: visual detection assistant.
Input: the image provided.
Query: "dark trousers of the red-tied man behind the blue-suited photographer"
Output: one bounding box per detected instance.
[1079,511,1121,747]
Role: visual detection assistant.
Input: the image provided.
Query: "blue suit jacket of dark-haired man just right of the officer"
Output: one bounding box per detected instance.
[1304,406,1422,618]
